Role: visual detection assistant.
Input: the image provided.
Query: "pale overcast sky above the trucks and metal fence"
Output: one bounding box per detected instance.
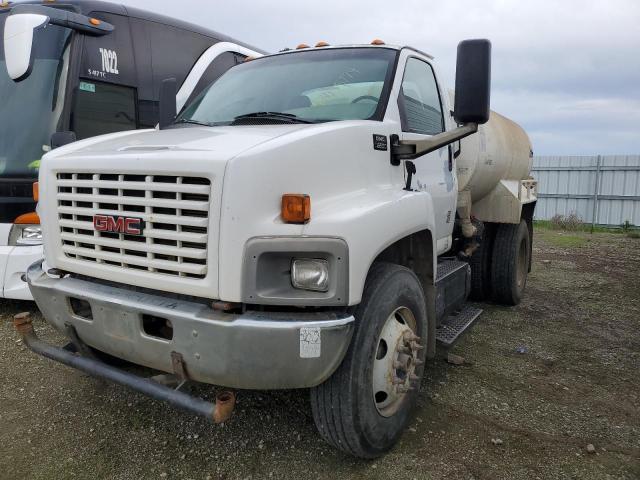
[119,0,640,155]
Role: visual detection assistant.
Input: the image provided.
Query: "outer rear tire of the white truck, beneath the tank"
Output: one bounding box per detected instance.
[491,220,531,305]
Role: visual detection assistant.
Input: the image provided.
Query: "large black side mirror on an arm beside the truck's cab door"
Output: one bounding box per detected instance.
[453,40,491,124]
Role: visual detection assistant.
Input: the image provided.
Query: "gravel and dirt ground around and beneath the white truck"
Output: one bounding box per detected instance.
[0,230,640,480]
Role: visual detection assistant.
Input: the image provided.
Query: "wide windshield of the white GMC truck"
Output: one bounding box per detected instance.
[177,48,397,125]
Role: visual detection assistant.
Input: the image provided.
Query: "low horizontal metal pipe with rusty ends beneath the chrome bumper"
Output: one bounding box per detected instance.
[13,314,236,423]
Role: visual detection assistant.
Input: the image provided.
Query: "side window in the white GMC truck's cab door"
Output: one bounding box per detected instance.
[398,58,444,135]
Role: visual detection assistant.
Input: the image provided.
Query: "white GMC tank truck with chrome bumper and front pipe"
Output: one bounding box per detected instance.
[16,40,536,458]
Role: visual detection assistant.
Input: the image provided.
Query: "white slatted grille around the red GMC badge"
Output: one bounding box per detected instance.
[57,173,211,278]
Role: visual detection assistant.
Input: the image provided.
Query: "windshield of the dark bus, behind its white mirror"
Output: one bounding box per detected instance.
[0,12,71,177]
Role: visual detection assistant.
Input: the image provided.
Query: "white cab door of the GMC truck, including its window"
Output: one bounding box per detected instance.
[397,55,458,253]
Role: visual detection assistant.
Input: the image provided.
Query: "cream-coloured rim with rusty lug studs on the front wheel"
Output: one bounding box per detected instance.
[373,307,423,417]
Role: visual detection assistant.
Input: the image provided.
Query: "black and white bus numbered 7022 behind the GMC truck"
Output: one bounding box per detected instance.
[0,0,260,300]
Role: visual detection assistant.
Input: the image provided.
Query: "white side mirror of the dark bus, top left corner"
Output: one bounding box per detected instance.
[3,13,49,82]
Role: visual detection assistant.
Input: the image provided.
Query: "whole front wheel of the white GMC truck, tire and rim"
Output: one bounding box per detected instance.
[311,263,428,458]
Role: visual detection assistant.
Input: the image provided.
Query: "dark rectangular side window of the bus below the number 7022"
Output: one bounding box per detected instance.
[72,80,137,140]
